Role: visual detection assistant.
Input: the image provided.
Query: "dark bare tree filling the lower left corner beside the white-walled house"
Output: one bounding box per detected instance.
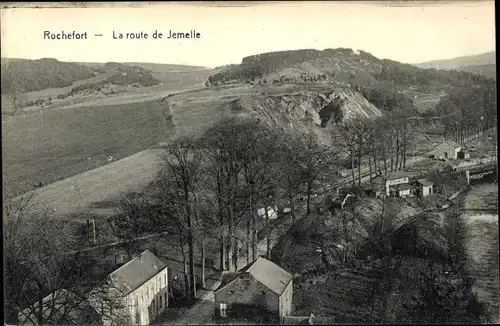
[3,199,126,325]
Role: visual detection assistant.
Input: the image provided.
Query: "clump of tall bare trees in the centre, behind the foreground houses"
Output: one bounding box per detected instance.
[112,118,332,296]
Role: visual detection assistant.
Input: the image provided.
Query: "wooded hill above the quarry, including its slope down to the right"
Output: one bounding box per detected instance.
[206,48,491,114]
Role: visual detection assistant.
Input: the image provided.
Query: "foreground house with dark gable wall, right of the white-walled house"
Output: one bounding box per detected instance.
[214,257,293,323]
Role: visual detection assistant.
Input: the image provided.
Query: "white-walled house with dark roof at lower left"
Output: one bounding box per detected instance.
[99,250,169,325]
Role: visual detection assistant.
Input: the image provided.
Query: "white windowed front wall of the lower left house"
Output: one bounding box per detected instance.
[120,268,168,325]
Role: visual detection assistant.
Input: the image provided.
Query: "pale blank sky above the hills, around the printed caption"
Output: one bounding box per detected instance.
[1,1,495,67]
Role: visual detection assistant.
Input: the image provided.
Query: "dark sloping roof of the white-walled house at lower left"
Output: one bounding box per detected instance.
[109,250,167,295]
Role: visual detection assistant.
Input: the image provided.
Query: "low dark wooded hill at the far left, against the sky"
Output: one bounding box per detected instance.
[1,58,95,94]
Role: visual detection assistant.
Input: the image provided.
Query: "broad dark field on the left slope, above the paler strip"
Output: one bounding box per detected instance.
[2,101,174,197]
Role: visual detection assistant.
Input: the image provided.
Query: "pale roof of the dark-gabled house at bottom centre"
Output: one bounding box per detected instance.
[215,257,293,295]
